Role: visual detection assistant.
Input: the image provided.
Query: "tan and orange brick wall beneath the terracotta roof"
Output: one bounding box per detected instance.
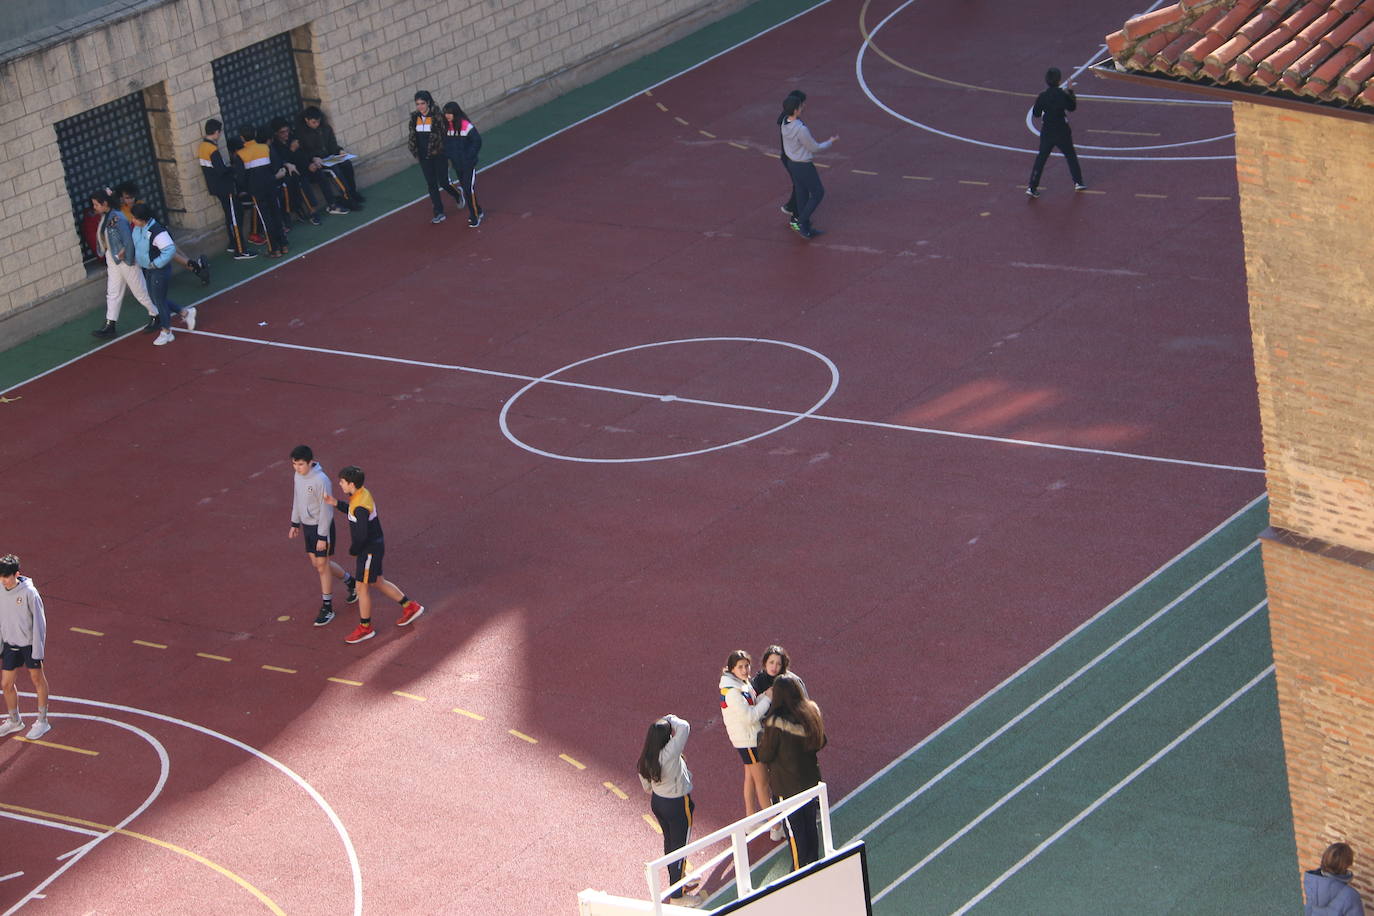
[1232,102,1374,894]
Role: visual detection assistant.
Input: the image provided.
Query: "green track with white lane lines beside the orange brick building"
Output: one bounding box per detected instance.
[824,501,1301,915]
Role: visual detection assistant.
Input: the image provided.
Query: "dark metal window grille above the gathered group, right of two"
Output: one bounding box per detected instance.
[210,32,301,136]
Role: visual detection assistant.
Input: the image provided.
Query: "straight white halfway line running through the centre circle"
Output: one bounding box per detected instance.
[179,331,1264,474]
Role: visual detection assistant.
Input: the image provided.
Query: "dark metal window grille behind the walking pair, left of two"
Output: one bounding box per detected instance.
[54,92,166,261]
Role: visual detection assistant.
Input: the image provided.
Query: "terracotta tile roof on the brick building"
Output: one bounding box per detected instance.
[1106,0,1374,114]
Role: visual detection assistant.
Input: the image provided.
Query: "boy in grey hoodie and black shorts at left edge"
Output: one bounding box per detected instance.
[0,553,52,742]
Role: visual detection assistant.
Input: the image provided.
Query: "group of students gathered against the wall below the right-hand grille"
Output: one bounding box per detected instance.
[196,106,364,260]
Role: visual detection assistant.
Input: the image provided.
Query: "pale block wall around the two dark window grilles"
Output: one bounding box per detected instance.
[0,0,746,336]
